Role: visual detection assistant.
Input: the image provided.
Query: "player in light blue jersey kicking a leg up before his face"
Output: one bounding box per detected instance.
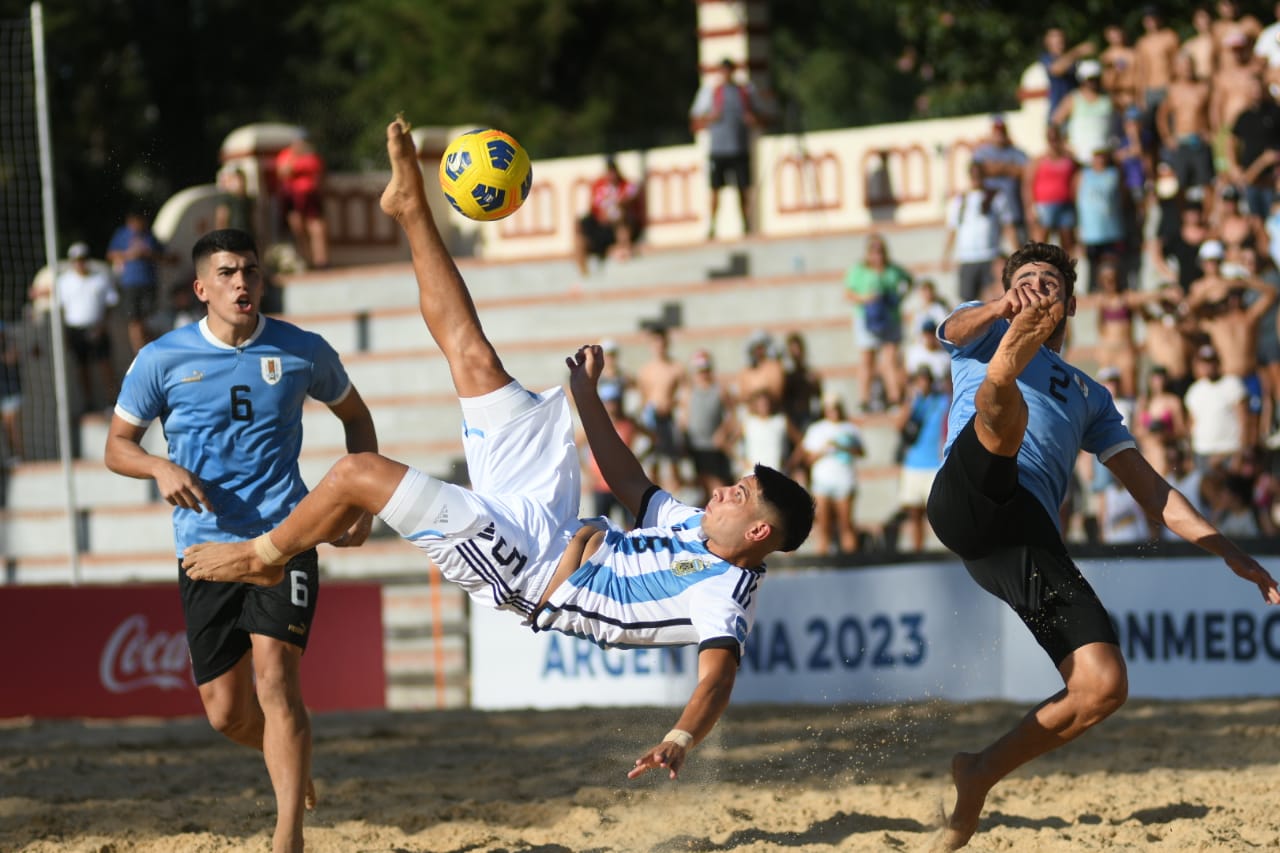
[927,236,1280,850]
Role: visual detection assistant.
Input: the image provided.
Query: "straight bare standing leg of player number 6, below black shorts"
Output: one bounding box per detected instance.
[252,634,311,853]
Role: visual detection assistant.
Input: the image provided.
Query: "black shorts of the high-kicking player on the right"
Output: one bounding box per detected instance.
[928,419,1120,666]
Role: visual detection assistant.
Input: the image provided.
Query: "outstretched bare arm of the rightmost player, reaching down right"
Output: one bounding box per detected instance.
[1106,447,1280,605]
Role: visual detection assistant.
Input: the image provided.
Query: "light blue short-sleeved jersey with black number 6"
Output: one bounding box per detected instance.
[115,316,351,557]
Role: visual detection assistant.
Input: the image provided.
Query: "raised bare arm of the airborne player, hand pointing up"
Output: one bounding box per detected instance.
[564,345,653,519]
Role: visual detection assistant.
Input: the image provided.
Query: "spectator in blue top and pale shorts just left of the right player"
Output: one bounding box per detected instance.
[896,363,951,553]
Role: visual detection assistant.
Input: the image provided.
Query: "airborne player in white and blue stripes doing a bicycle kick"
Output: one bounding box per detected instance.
[183,119,813,777]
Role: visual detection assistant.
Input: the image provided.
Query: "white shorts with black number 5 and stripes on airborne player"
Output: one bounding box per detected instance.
[378,383,581,616]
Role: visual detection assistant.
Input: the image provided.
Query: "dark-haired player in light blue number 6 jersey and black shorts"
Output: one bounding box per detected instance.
[104,228,378,853]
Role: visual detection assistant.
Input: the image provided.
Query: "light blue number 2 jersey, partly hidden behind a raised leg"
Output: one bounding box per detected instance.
[938,302,1137,524]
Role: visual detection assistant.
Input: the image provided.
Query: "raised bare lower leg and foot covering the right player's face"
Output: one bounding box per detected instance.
[974,298,1066,456]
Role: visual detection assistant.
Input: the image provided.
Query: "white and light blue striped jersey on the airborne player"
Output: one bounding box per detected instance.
[535,491,764,657]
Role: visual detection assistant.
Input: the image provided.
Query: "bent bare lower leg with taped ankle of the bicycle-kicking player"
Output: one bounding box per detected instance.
[182,453,408,587]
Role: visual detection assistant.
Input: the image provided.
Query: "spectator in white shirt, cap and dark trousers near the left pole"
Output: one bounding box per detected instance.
[56,243,119,411]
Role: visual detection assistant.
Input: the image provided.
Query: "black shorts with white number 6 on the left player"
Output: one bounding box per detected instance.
[178,548,320,684]
